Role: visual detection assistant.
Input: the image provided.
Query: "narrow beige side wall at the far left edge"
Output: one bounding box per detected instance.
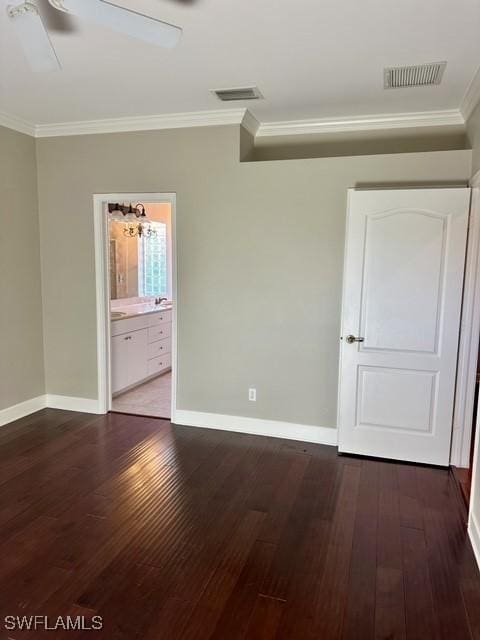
[0,127,45,410]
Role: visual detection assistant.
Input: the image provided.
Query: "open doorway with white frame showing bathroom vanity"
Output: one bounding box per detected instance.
[94,194,176,419]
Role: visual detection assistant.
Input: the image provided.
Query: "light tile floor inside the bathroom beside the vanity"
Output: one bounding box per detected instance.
[112,371,172,418]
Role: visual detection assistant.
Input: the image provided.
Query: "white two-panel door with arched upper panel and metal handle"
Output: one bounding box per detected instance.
[338,188,470,465]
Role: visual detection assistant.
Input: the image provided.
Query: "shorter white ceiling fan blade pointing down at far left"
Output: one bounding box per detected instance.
[7,2,60,73]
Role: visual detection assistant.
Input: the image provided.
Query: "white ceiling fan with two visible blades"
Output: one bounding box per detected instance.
[7,0,182,72]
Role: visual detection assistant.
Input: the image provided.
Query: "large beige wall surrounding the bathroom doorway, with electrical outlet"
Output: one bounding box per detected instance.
[38,126,471,427]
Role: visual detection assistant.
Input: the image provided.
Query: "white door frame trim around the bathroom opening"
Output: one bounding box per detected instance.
[93,192,178,422]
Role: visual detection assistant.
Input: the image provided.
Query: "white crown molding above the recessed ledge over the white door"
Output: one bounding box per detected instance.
[257,109,465,138]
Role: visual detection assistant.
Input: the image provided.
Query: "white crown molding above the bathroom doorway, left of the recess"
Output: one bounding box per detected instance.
[35,109,246,138]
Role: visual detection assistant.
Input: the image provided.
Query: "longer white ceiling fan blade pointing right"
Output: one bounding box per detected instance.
[48,0,182,48]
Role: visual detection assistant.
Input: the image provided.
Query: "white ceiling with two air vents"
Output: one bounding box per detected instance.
[0,0,480,124]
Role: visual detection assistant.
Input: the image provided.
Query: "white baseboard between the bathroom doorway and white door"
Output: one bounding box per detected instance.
[172,409,338,447]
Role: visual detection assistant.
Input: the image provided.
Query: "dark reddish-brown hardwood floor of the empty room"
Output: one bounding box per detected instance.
[0,409,480,640]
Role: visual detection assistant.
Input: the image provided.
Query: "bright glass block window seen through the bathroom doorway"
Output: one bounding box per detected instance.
[138,222,168,298]
